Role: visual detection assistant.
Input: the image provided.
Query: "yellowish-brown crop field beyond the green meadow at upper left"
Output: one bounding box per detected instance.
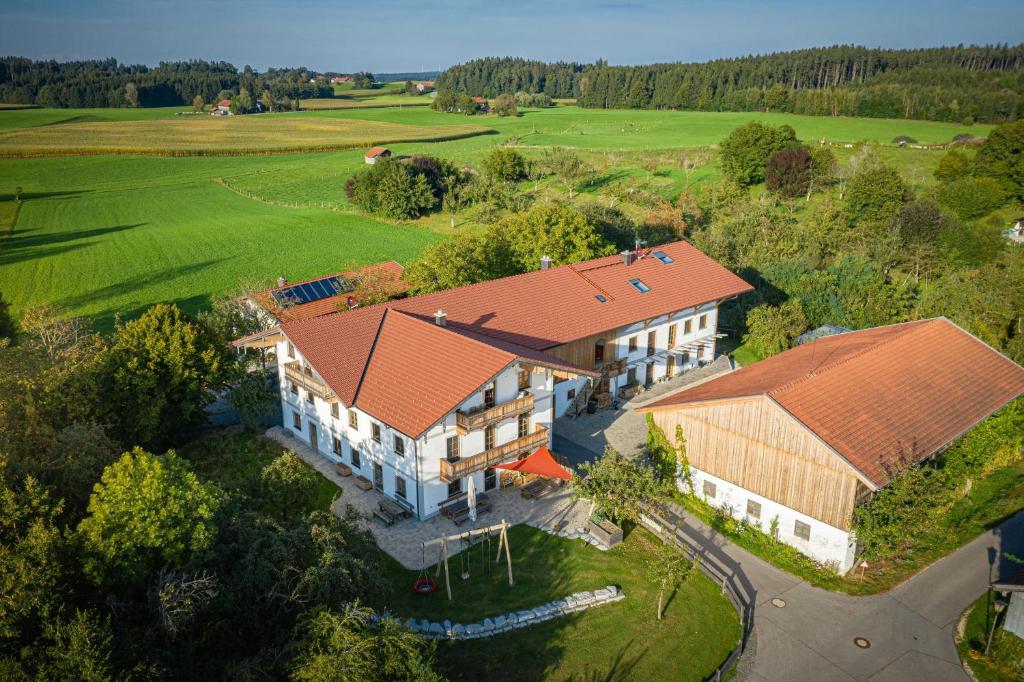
[0,114,488,157]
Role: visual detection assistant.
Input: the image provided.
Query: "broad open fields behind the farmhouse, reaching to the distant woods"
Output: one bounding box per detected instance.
[0,102,990,329]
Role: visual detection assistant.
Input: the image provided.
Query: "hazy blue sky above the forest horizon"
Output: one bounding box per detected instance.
[0,0,1024,72]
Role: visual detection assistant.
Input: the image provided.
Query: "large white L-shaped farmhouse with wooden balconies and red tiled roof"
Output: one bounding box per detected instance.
[237,242,751,518]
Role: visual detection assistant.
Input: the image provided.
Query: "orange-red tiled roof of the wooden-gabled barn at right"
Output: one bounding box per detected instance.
[639,317,1024,485]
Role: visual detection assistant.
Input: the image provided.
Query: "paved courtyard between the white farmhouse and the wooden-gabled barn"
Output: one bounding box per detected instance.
[553,355,732,456]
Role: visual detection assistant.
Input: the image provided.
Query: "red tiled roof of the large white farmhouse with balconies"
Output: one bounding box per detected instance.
[282,242,751,436]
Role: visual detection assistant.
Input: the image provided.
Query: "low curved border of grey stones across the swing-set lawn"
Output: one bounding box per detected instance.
[395,585,626,640]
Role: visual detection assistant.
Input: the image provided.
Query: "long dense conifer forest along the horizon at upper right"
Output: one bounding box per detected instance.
[436,44,1024,123]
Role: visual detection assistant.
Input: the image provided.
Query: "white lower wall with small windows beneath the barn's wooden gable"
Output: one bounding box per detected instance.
[677,467,856,573]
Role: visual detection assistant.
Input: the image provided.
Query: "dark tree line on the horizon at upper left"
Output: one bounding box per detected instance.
[0,56,334,109]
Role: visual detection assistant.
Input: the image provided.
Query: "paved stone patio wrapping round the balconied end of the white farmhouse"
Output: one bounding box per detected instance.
[266,426,590,570]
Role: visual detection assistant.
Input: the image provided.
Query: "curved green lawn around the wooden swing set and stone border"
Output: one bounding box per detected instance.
[372,525,739,680]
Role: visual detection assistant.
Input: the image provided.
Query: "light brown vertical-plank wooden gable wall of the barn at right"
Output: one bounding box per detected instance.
[652,396,859,530]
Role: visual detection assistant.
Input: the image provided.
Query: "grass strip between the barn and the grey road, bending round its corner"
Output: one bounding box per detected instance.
[677,462,1024,595]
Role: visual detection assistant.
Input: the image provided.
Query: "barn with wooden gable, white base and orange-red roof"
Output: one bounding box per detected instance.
[638,317,1024,572]
